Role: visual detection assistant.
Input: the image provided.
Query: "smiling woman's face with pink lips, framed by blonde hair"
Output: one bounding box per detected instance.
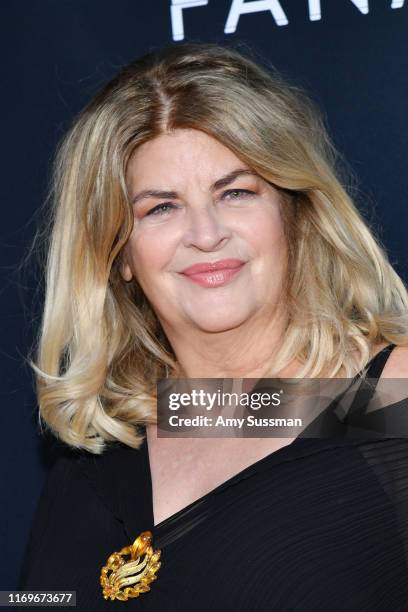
[121,129,286,337]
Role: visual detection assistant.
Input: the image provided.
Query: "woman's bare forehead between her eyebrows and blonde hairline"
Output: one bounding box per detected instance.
[126,129,249,188]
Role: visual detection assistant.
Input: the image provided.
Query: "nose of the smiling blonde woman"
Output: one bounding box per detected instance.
[183,203,231,251]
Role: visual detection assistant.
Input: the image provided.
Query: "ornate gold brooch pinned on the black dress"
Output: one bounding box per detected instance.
[100,531,161,601]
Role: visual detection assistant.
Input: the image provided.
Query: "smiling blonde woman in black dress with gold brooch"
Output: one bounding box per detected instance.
[20,44,408,611]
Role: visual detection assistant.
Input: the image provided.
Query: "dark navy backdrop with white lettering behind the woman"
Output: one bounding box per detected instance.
[0,0,408,589]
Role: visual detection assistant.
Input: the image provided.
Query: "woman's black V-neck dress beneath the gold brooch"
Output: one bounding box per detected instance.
[19,345,408,612]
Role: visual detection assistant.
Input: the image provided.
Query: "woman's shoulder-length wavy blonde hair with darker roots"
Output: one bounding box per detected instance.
[29,43,408,453]
